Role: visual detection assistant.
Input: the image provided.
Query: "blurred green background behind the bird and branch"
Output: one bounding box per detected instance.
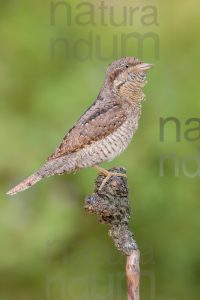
[0,0,200,300]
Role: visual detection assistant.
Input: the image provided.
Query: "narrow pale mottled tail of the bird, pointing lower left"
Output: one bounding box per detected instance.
[6,172,44,195]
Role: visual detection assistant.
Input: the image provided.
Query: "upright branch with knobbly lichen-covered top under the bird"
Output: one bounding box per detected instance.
[85,167,140,300]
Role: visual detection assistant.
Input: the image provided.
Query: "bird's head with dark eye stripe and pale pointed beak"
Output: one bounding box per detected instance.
[107,57,153,96]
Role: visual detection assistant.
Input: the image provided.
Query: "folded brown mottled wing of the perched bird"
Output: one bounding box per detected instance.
[48,100,126,160]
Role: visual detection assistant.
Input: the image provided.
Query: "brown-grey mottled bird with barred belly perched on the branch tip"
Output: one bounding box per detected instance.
[7,56,153,195]
